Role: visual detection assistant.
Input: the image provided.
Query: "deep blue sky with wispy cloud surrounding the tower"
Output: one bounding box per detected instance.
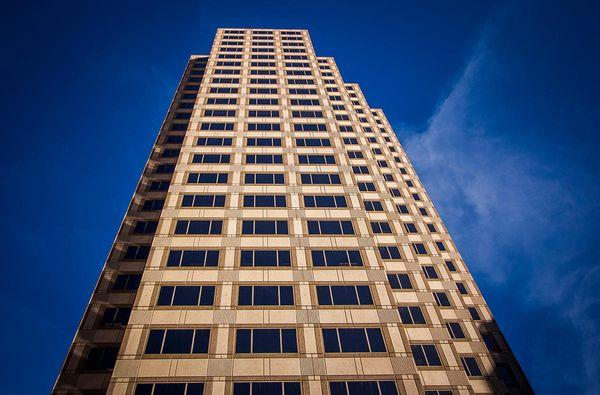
[0,0,600,394]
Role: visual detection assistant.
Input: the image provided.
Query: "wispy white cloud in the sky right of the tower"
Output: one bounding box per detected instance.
[397,10,600,394]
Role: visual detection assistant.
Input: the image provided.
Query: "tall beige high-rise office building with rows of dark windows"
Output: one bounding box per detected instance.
[54,29,531,395]
